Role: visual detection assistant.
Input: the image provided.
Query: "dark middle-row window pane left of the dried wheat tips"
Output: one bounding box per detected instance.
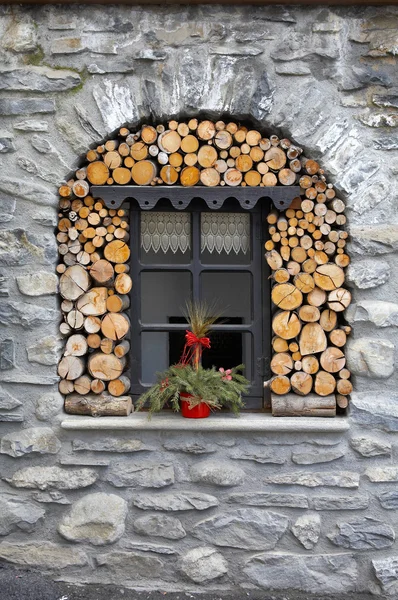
[141,271,192,323]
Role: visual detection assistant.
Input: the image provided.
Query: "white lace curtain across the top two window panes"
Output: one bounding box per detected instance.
[141,212,250,254]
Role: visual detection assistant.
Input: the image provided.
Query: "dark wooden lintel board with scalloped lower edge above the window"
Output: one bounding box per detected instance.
[91,185,300,210]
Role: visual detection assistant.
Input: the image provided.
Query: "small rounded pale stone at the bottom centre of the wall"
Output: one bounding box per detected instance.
[180,546,228,583]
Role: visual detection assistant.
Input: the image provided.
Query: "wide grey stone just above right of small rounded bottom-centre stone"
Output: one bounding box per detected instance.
[192,508,289,550]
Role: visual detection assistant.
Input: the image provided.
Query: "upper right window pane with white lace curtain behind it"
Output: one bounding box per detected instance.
[201,211,250,265]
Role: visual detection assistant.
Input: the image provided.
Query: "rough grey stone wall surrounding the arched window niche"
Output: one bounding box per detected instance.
[0,6,398,595]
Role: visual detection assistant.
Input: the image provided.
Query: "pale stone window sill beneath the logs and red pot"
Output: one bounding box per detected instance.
[61,413,350,433]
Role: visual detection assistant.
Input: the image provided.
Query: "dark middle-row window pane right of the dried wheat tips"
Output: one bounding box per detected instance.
[201,271,252,323]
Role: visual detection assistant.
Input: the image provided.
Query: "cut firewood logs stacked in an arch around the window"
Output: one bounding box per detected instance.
[57,119,352,414]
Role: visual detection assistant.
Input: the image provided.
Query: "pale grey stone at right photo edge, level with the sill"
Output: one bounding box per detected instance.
[351,392,398,431]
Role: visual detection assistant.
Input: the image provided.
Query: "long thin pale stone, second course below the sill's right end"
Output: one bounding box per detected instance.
[264,471,359,488]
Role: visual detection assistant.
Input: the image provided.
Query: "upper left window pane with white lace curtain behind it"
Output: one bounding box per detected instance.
[141,211,191,264]
